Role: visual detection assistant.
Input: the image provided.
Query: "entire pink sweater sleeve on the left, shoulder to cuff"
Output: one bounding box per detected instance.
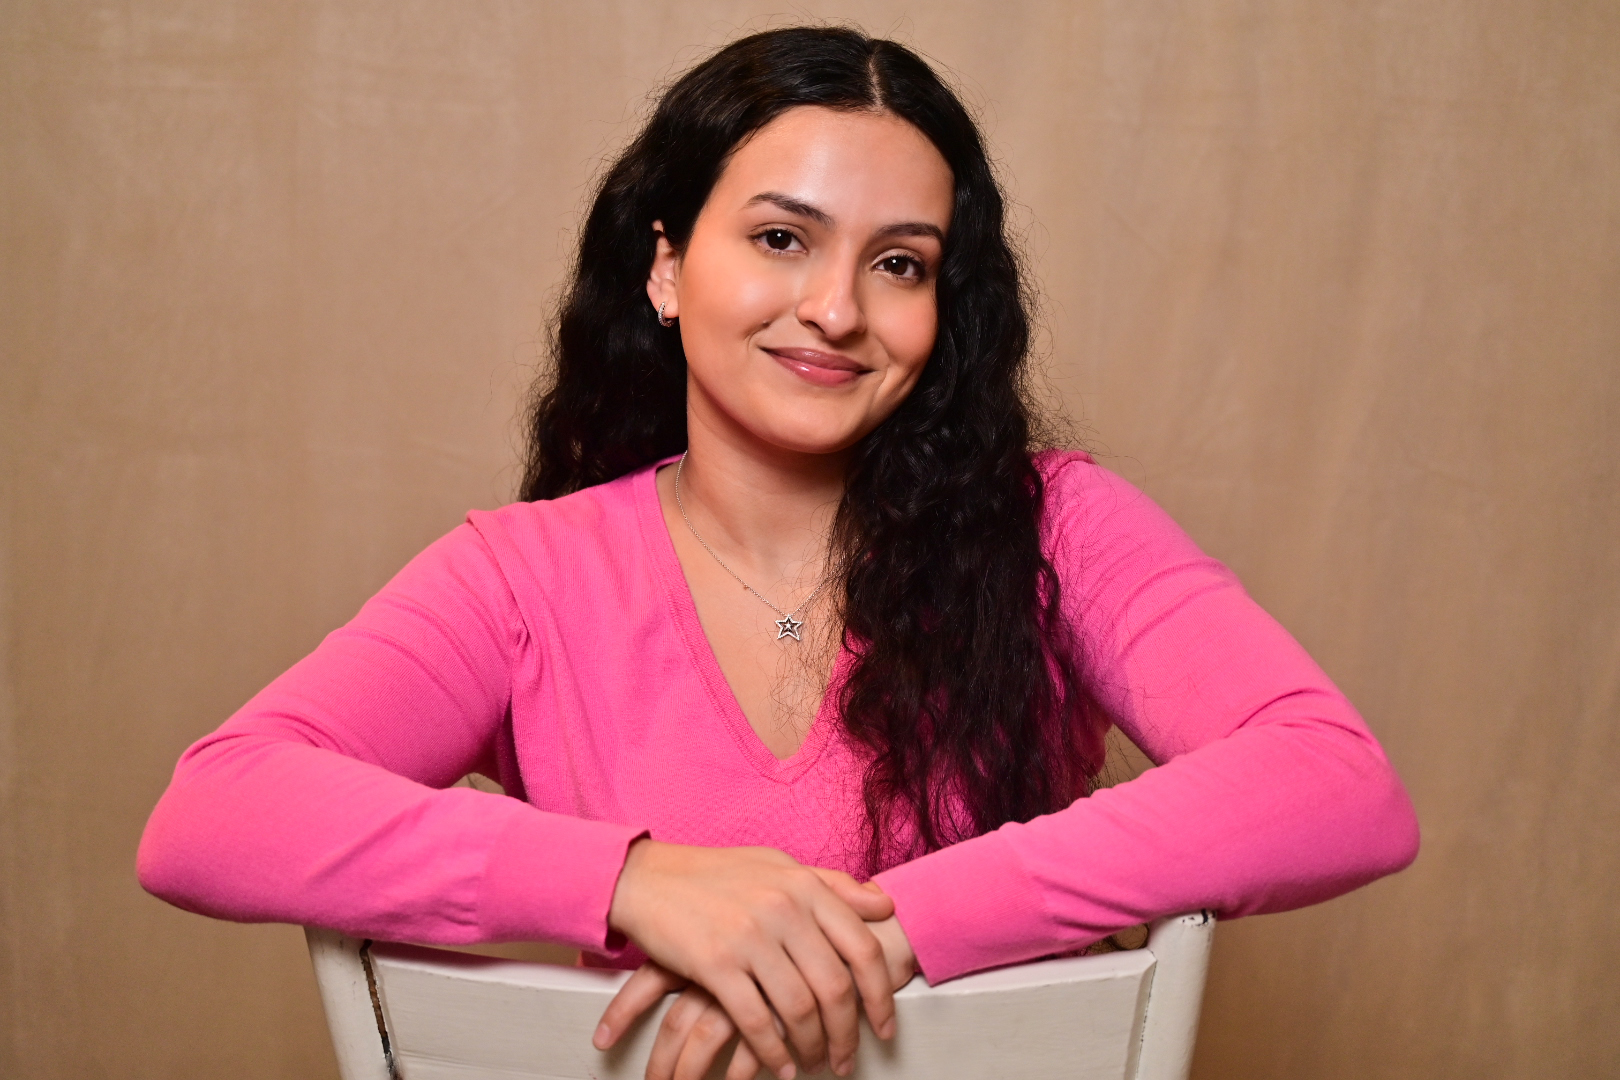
[138,525,642,950]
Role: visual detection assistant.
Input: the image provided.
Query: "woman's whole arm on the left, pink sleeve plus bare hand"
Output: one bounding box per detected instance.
[138,526,893,1067]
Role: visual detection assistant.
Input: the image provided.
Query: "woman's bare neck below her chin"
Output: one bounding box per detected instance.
[671,401,849,586]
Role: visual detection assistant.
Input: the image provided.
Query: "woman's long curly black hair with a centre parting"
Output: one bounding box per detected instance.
[522,28,1103,871]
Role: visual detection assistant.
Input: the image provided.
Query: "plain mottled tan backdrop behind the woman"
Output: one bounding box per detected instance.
[0,0,1620,1080]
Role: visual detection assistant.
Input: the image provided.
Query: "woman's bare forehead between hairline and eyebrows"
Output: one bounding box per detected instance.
[710,105,954,230]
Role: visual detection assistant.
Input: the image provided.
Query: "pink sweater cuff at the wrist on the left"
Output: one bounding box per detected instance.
[478,806,646,952]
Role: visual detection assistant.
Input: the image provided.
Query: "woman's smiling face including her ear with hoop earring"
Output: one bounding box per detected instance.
[648,107,953,453]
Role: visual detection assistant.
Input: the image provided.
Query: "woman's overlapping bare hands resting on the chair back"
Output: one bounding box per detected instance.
[593,840,915,1080]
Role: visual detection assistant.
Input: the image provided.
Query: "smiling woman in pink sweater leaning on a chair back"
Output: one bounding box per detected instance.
[139,29,1418,1078]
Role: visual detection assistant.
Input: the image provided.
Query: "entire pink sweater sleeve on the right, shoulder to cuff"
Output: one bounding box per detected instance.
[876,457,1418,981]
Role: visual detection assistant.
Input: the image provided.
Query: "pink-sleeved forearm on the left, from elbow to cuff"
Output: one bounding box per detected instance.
[138,737,638,950]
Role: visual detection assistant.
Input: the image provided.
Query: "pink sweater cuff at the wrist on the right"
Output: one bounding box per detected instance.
[873,832,1063,984]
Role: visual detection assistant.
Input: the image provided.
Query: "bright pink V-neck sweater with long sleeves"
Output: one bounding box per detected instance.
[138,453,1418,983]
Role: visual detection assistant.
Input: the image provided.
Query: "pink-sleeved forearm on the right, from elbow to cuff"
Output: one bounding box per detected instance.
[875,712,1418,981]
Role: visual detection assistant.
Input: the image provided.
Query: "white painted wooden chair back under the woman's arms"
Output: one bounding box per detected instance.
[306,912,1215,1080]
